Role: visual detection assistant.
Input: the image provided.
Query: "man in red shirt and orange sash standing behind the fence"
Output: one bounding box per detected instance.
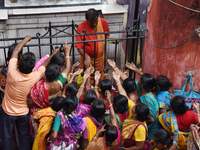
[75,9,109,82]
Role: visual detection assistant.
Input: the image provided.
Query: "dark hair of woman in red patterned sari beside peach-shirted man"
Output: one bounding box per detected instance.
[45,64,61,82]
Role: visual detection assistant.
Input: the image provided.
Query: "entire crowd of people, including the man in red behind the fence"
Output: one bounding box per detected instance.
[0,9,200,150]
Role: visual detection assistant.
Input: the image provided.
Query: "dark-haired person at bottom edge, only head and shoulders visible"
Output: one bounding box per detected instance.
[149,129,177,150]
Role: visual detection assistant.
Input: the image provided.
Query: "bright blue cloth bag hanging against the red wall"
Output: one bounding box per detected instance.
[174,74,200,108]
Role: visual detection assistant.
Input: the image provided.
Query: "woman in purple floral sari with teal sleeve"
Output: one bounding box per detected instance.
[46,94,83,150]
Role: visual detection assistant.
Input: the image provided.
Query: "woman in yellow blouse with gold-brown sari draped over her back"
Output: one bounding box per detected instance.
[121,103,150,150]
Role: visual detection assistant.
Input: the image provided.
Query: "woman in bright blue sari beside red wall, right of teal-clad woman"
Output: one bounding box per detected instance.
[155,75,173,114]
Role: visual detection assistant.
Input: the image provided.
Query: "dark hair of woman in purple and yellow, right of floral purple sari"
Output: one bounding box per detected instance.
[90,100,106,122]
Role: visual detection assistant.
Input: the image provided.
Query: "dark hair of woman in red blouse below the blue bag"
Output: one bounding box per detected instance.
[170,96,189,115]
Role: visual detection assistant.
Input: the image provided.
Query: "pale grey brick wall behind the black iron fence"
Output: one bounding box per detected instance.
[0,12,124,65]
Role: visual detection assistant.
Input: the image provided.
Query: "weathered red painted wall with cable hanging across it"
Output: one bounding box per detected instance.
[143,0,200,91]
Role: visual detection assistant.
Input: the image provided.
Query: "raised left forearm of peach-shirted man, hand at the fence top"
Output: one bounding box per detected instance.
[11,35,32,59]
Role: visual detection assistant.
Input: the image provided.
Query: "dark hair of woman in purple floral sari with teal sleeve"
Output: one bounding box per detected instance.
[62,94,78,114]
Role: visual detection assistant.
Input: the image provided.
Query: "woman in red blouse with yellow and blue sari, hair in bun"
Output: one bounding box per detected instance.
[159,96,200,150]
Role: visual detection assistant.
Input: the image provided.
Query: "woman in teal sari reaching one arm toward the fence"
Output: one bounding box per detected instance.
[126,63,161,140]
